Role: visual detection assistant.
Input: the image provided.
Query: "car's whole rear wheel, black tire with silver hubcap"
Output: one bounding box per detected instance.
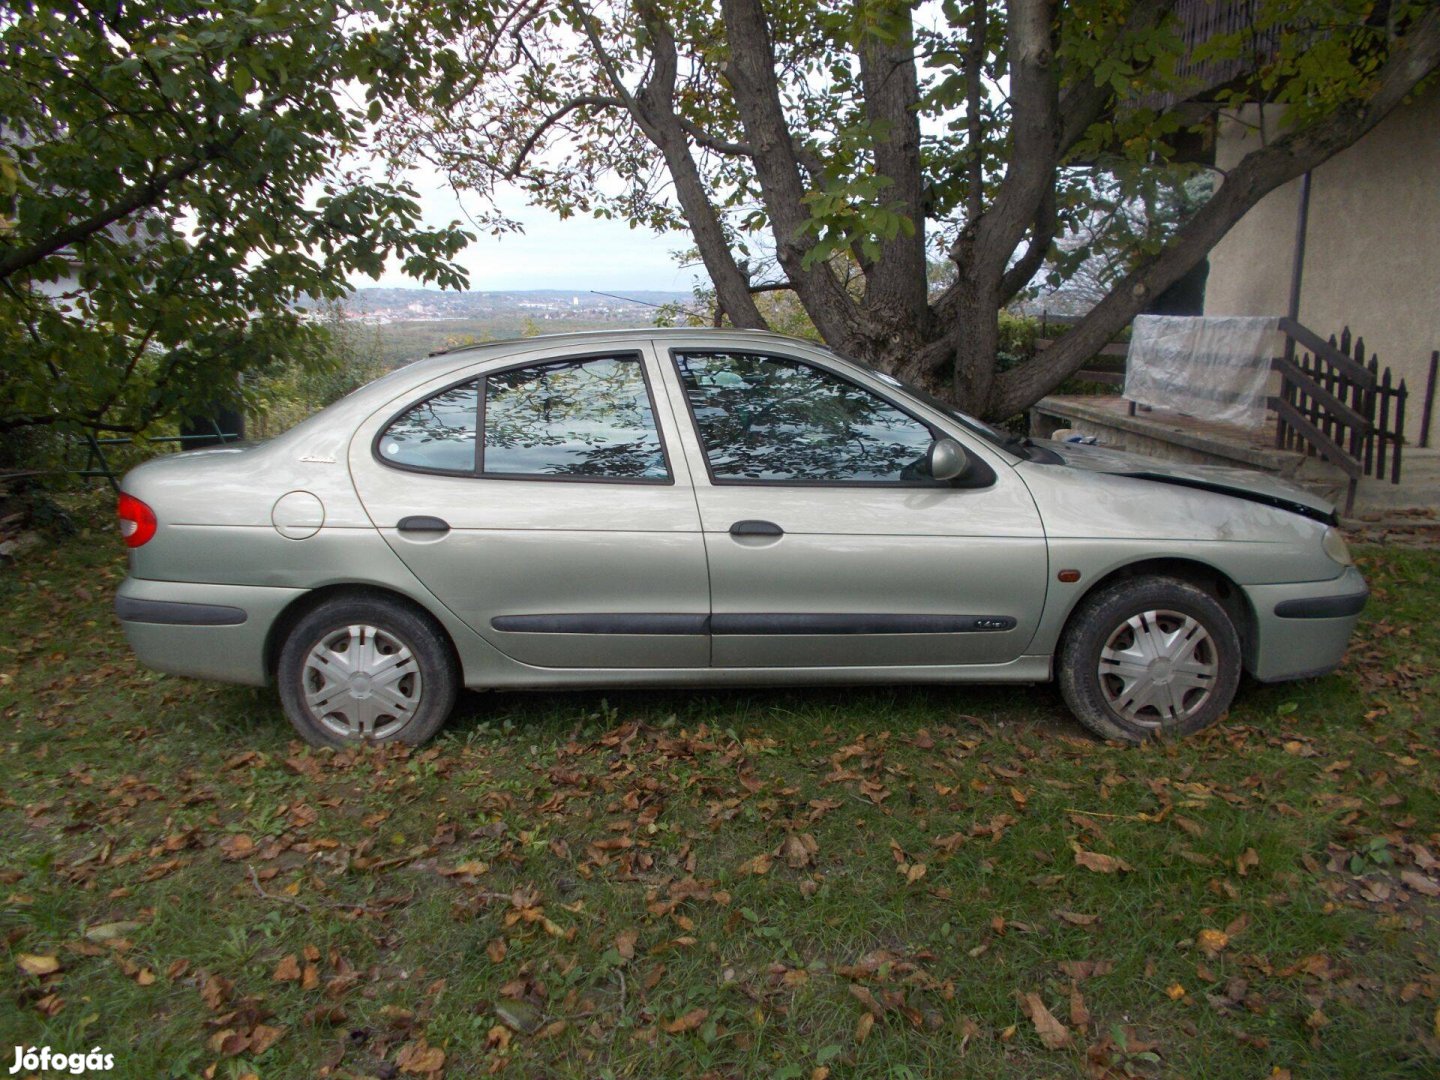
[275,595,459,747]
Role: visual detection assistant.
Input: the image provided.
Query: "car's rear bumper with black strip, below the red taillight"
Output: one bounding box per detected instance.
[115,577,305,685]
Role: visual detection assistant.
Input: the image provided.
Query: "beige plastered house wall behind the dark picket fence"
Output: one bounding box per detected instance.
[1205,85,1440,444]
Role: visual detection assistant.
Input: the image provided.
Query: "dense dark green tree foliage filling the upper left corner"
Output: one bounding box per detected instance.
[0,0,468,452]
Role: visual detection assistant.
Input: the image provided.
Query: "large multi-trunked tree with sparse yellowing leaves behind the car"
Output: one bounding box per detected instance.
[386,0,1440,418]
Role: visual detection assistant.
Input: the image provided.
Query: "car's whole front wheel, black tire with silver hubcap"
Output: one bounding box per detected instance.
[1057,576,1241,743]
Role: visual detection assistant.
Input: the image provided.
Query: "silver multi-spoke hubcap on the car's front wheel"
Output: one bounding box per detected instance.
[1100,611,1220,727]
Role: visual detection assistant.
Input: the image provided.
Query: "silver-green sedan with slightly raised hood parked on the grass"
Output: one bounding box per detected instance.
[115,330,1367,744]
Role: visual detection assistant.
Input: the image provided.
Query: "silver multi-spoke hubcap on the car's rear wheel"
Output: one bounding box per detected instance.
[301,624,420,739]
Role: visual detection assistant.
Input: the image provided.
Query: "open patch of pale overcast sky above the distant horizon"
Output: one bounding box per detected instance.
[351,173,697,292]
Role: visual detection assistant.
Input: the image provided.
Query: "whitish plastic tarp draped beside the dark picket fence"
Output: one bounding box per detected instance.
[1125,315,1280,428]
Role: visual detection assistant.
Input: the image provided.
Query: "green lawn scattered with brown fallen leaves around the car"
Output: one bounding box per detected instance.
[0,509,1440,1079]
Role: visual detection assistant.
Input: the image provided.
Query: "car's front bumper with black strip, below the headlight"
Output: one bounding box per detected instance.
[1244,566,1369,683]
